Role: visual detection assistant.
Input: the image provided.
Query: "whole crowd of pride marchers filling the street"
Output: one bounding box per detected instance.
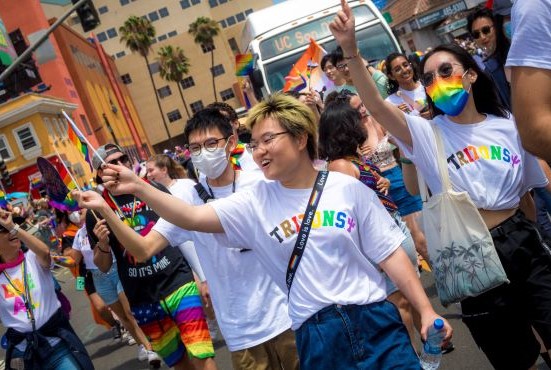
[0,0,551,370]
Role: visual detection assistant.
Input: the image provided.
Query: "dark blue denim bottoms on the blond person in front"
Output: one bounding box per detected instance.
[295,301,421,370]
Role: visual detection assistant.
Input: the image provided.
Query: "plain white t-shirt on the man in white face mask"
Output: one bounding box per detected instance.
[153,171,291,352]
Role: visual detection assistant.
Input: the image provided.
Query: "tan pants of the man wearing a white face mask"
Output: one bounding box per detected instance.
[231,329,299,370]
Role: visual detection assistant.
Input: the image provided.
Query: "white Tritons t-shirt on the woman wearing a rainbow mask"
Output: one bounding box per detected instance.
[395,114,547,210]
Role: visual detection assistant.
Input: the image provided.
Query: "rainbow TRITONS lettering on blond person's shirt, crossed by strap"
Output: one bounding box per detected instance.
[269,210,356,243]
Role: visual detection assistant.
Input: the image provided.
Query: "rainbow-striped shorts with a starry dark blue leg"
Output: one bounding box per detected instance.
[132,282,214,367]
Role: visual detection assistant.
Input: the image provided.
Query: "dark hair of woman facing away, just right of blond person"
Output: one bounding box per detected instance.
[318,99,367,161]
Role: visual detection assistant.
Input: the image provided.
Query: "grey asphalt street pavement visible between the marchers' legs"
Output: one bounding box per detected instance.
[0,268,548,370]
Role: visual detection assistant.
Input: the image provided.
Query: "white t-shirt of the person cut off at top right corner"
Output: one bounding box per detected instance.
[505,0,551,69]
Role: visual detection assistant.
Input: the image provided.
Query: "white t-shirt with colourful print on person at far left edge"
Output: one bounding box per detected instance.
[0,251,61,333]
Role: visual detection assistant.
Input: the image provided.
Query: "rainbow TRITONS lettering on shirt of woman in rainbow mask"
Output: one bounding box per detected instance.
[447,145,521,169]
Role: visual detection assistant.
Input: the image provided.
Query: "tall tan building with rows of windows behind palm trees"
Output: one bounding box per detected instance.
[41,0,274,151]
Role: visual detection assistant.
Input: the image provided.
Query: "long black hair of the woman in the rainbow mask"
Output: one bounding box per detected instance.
[420,44,509,118]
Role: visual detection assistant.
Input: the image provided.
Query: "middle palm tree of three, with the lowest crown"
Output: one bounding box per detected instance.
[157,45,191,118]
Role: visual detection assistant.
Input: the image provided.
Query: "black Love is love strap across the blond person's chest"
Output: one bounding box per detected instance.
[286,171,329,296]
